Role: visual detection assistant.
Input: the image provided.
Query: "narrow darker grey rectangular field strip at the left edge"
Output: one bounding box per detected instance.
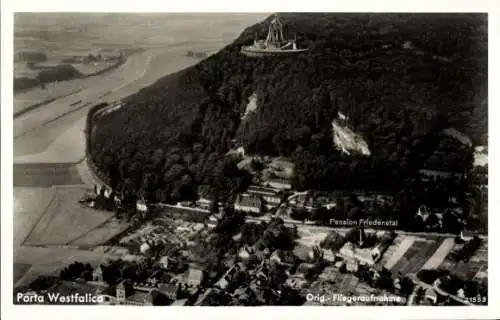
[13,163,82,187]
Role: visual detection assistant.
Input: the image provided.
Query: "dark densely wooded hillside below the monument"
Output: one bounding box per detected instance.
[91,13,487,200]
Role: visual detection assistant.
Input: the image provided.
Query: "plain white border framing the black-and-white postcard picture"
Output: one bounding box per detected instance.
[1,0,500,320]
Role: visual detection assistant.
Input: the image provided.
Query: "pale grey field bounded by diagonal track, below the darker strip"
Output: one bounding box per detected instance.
[25,187,117,245]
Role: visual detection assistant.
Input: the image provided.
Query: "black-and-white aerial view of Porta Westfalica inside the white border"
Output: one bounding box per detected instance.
[9,12,489,310]
